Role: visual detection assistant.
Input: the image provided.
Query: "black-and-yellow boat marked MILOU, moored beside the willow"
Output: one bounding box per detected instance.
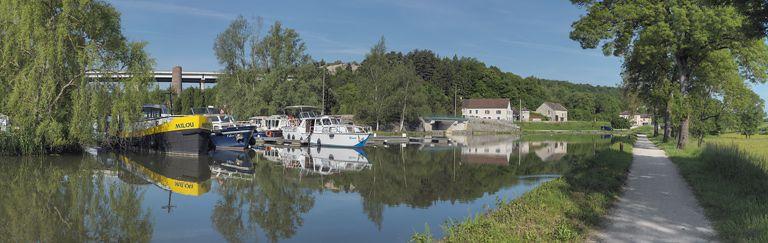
[122,105,211,156]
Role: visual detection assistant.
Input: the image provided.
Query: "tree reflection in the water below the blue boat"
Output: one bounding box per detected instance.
[211,155,315,242]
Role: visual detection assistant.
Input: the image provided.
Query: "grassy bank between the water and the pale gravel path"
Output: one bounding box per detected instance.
[413,137,632,242]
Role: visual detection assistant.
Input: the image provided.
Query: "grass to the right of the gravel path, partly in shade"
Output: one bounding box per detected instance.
[654,134,768,242]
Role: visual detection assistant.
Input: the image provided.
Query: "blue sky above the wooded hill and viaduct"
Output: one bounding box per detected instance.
[108,0,768,110]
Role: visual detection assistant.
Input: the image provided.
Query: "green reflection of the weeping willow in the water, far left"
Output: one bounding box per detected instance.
[0,157,152,242]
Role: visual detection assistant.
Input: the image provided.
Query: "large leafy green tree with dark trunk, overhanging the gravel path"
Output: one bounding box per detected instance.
[571,0,768,147]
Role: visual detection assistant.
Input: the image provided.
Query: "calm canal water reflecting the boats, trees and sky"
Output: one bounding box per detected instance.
[0,136,610,242]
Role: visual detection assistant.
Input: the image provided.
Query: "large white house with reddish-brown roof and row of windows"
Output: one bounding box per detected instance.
[461,99,515,121]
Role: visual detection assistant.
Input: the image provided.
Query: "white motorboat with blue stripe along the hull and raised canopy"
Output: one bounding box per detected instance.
[282,106,371,147]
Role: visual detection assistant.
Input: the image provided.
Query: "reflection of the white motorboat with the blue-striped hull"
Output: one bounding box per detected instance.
[257,146,371,175]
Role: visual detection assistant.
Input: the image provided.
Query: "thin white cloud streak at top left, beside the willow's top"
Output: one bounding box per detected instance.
[109,0,236,20]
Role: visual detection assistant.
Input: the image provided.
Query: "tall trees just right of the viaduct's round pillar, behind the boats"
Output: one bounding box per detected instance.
[213,16,322,117]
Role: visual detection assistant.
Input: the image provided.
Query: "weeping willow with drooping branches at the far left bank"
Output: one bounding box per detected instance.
[0,0,152,153]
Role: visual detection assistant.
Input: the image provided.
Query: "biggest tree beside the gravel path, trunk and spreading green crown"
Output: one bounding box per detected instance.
[571,0,768,148]
